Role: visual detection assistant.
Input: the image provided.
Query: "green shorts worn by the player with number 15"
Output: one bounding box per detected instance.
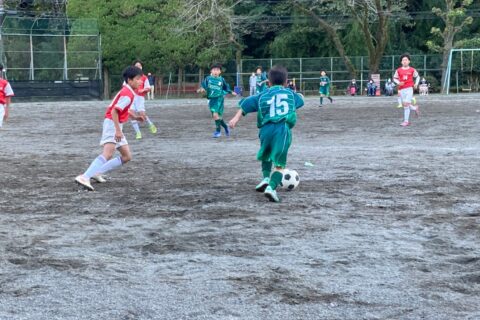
[257,122,292,168]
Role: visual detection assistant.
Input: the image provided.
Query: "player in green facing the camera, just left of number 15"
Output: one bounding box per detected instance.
[200,64,237,138]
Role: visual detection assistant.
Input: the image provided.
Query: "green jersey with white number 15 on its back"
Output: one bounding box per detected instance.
[239,86,304,128]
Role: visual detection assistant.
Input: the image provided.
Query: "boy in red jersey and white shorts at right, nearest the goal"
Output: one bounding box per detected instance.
[393,53,420,127]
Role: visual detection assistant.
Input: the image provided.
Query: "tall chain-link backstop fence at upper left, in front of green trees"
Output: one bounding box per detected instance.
[0,16,102,96]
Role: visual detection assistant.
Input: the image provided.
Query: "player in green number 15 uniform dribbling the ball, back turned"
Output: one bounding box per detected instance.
[229,66,304,202]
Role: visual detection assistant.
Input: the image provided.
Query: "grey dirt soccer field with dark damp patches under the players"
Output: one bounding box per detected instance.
[0,95,480,320]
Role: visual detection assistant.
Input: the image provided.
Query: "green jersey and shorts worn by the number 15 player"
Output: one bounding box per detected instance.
[239,86,304,169]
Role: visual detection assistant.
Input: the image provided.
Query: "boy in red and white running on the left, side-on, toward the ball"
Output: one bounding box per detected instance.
[75,66,145,191]
